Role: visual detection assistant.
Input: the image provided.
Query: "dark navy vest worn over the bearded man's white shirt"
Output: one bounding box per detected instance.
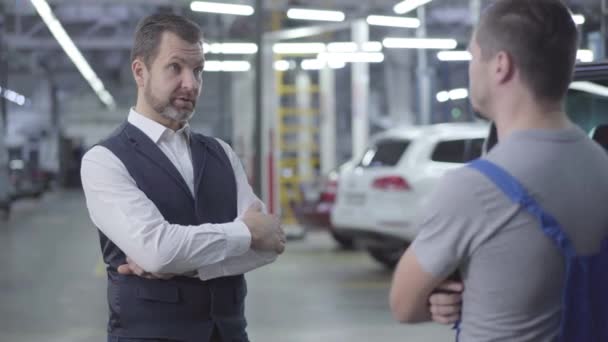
[100,122,248,342]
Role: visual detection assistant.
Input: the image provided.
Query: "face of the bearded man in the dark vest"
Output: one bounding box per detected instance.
[144,32,205,123]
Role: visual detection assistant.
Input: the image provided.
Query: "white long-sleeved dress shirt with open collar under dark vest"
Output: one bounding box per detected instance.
[81,109,276,280]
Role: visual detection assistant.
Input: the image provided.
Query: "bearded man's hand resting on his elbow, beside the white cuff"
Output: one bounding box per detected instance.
[242,202,285,254]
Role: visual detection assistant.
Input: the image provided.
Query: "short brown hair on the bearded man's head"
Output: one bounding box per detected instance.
[131,14,203,66]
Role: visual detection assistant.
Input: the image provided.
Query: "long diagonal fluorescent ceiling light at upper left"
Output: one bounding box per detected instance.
[30,0,116,109]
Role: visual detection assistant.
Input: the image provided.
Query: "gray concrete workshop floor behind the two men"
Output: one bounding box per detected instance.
[0,191,454,342]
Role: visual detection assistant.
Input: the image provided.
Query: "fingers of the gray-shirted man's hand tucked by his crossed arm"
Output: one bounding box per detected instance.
[429,280,464,324]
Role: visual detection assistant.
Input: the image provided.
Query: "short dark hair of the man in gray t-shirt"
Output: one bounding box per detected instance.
[475,0,578,101]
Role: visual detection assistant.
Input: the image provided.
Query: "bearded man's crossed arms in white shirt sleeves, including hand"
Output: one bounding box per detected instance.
[81,140,284,280]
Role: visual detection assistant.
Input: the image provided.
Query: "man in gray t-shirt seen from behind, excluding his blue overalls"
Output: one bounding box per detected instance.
[390,0,608,342]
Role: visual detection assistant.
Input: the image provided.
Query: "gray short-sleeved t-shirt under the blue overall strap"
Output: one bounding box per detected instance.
[412,128,608,342]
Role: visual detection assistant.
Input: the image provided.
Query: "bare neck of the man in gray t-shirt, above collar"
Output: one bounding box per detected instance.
[494,96,572,140]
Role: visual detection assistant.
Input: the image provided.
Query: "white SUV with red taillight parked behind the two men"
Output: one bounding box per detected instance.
[331,123,489,267]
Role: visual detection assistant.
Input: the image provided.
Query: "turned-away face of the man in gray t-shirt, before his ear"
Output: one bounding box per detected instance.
[469,34,491,117]
